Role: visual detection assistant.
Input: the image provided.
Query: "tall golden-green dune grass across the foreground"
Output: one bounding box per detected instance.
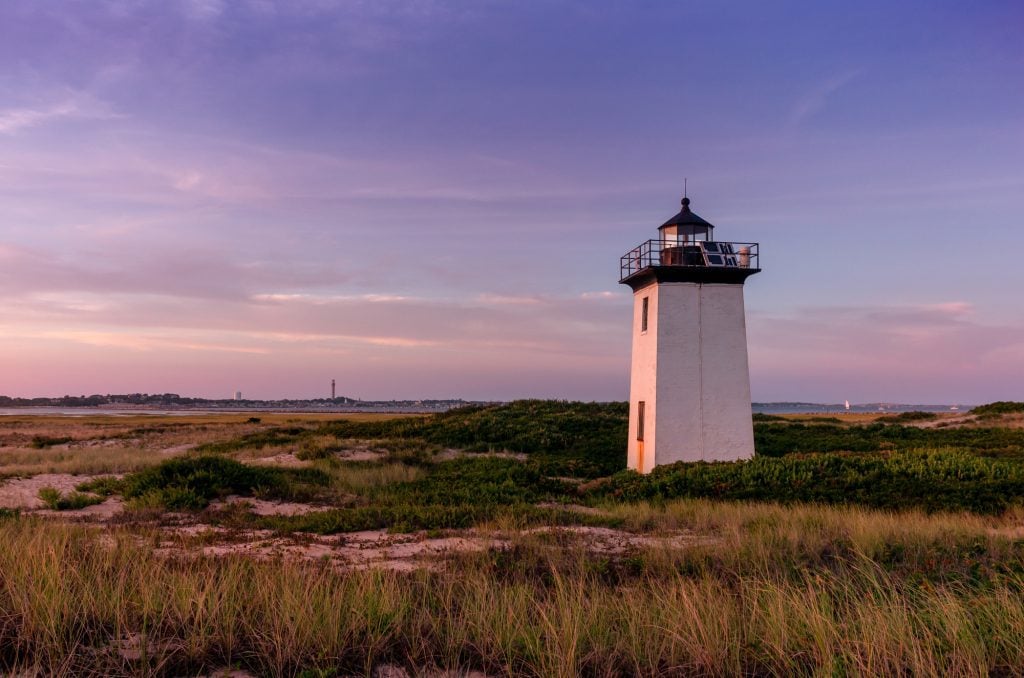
[0,501,1024,676]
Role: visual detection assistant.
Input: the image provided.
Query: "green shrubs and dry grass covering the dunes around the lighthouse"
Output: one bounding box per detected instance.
[6,400,1024,676]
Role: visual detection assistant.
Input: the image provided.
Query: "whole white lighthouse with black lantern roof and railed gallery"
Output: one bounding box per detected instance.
[620,198,761,473]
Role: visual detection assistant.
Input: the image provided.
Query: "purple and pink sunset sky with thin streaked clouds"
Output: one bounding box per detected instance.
[0,0,1024,402]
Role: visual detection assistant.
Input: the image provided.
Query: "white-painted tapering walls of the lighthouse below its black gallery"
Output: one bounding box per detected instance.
[629,283,754,473]
